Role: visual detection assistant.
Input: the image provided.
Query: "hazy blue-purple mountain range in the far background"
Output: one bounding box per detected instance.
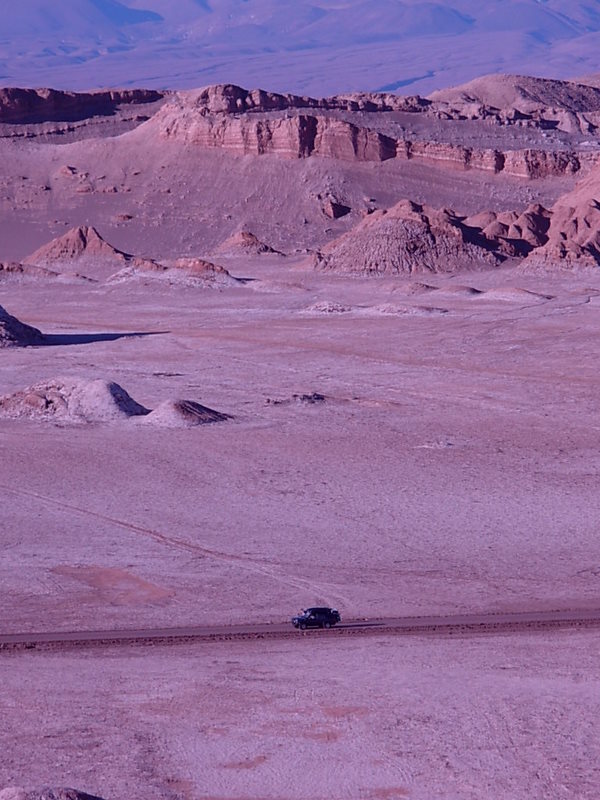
[0,0,600,95]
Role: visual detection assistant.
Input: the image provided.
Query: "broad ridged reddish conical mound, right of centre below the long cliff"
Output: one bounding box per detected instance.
[315,200,500,275]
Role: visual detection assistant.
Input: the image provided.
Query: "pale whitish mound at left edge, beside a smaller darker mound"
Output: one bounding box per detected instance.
[0,378,150,423]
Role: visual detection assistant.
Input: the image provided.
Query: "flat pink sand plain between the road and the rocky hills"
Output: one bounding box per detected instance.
[0,259,600,631]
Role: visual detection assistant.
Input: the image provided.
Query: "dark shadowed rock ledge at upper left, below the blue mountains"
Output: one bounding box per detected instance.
[0,88,165,125]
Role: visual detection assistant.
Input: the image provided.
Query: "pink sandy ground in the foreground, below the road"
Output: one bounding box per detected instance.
[0,631,600,800]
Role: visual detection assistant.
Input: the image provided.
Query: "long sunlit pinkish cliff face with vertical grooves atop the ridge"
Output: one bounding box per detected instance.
[152,86,592,178]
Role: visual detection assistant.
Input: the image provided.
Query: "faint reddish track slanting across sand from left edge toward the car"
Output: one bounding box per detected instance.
[0,484,350,605]
